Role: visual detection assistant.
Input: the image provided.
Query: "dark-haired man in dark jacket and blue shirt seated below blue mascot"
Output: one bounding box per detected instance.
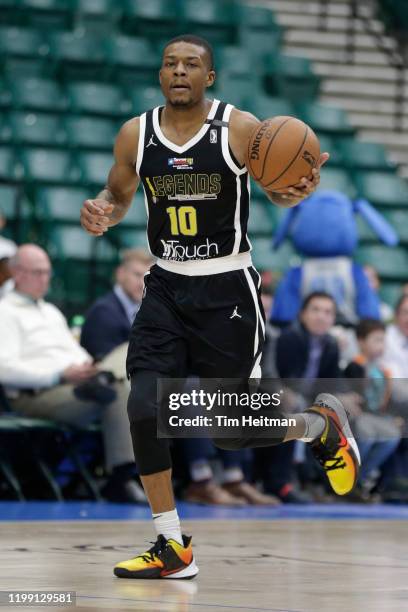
[255,291,340,503]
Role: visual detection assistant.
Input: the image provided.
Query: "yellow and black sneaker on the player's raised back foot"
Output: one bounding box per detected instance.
[306,393,361,495]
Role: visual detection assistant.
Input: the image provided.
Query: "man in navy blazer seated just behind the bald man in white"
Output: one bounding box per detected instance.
[81,249,153,363]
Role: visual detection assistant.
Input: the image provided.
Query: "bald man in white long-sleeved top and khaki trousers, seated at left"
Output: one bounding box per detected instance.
[0,244,142,501]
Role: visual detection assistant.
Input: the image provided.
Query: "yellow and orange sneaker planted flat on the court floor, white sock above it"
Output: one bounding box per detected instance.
[113,534,198,580]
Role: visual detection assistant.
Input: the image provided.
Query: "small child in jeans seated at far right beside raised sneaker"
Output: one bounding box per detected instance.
[344,319,401,501]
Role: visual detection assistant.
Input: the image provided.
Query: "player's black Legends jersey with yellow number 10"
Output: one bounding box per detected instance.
[136,100,251,262]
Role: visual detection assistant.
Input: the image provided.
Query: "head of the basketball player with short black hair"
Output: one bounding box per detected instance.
[160,41,215,107]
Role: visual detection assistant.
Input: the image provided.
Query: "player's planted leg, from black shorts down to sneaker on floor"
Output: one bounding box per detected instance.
[114,269,198,578]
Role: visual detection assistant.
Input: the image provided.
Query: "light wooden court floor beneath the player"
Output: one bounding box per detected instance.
[0,520,408,612]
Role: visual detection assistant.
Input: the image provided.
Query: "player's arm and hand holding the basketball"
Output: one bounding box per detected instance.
[230,108,329,208]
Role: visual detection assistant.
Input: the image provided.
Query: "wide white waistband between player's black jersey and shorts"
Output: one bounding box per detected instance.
[156,251,252,276]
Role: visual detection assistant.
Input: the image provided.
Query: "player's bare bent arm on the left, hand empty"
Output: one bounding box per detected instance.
[81,117,140,236]
